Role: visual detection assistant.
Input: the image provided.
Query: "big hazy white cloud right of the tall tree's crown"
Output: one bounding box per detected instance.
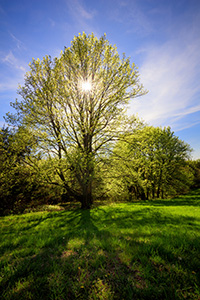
[131,30,200,130]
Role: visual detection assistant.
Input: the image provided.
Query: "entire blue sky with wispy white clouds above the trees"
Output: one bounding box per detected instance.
[0,0,200,159]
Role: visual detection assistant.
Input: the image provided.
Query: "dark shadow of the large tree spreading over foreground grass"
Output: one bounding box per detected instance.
[1,208,200,300]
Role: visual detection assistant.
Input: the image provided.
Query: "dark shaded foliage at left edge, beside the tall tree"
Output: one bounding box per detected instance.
[0,127,59,215]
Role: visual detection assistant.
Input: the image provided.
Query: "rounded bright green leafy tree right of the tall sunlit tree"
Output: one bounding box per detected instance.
[111,126,193,200]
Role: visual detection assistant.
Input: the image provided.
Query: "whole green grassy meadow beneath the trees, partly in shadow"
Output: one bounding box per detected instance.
[0,190,200,300]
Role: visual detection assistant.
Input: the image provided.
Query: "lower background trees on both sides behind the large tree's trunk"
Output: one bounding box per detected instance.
[0,121,200,215]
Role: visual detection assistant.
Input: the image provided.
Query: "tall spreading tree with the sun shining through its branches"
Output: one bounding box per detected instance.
[7,33,145,208]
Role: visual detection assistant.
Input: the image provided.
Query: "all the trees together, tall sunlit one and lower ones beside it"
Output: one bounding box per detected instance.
[0,33,199,213]
